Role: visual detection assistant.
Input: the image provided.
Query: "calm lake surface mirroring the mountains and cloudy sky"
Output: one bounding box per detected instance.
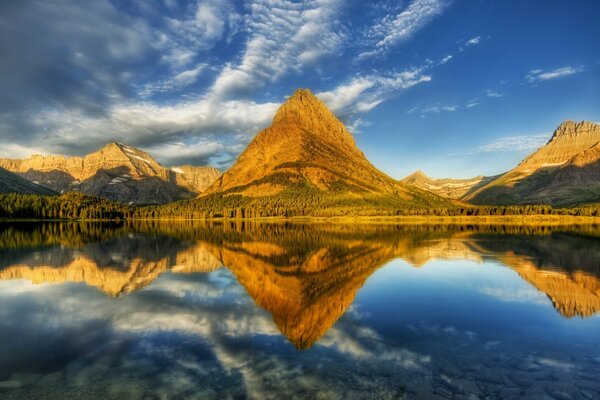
[0,223,600,399]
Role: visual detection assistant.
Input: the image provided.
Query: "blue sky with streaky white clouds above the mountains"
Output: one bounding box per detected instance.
[0,0,600,178]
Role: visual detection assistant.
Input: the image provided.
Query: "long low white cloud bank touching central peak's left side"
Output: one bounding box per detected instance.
[25,97,279,164]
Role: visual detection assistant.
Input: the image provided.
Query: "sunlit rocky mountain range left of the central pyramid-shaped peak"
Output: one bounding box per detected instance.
[0,143,219,204]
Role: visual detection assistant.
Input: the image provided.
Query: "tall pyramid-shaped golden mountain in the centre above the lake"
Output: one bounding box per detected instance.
[180,89,452,216]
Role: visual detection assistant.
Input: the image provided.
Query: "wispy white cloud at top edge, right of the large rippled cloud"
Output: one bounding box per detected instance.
[359,0,449,59]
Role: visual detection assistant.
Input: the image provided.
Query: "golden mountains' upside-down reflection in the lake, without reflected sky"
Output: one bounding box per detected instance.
[0,222,600,349]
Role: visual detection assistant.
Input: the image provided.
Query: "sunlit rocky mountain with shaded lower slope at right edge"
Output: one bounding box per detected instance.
[463,121,600,206]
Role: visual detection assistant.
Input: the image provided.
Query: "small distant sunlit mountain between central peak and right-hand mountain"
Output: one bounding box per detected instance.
[400,171,495,199]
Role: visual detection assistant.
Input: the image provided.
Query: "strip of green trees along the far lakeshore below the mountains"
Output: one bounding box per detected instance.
[0,191,600,220]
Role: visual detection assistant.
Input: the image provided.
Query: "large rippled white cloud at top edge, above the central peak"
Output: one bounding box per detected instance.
[212,0,344,98]
